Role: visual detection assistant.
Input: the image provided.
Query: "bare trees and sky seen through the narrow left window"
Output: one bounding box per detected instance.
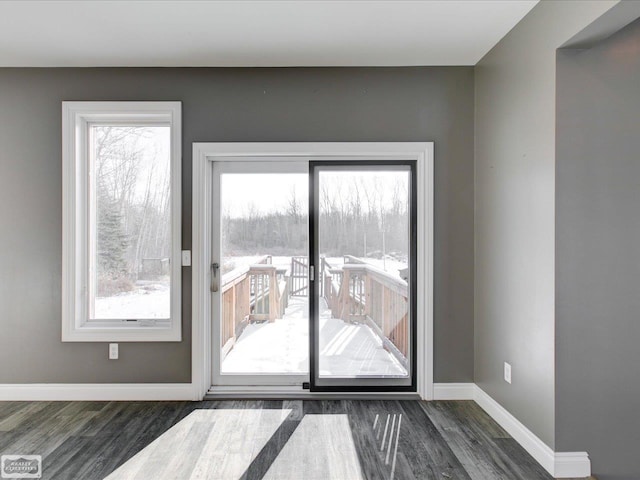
[92,125,171,289]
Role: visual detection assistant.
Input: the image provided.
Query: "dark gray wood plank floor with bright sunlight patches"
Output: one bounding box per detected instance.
[0,400,564,480]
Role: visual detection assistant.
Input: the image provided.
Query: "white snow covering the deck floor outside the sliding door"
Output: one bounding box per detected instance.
[222,297,407,377]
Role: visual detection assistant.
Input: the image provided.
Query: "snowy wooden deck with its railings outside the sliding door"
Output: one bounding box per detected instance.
[221,255,410,378]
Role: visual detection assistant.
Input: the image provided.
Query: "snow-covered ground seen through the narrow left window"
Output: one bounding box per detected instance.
[95,283,171,320]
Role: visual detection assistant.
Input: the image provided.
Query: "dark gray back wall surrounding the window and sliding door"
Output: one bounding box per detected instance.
[0,67,474,383]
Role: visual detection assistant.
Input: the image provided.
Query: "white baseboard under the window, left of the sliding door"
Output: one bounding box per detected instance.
[0,383,200,401]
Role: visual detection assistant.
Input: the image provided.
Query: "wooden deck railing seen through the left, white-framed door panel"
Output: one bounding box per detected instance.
[221,255,289,355]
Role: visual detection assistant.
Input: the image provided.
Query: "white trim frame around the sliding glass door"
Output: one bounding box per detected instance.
[191,142,433,400]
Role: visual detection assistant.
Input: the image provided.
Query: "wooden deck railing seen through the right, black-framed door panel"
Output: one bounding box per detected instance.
[320,256,409,367]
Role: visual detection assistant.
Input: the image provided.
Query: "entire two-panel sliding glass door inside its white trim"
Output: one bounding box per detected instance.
[211,159,416,391]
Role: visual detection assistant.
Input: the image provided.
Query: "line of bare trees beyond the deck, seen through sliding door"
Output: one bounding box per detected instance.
[222,176,409,260]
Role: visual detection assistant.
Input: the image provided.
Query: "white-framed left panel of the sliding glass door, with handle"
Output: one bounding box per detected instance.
[212,161,309,385]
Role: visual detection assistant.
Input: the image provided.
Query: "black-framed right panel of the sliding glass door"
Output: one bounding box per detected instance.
[311,162,416,390]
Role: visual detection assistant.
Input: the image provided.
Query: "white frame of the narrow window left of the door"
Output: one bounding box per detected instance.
[62,102,182,342]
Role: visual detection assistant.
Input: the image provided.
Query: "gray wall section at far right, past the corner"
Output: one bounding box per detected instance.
[556,16,640,480]
